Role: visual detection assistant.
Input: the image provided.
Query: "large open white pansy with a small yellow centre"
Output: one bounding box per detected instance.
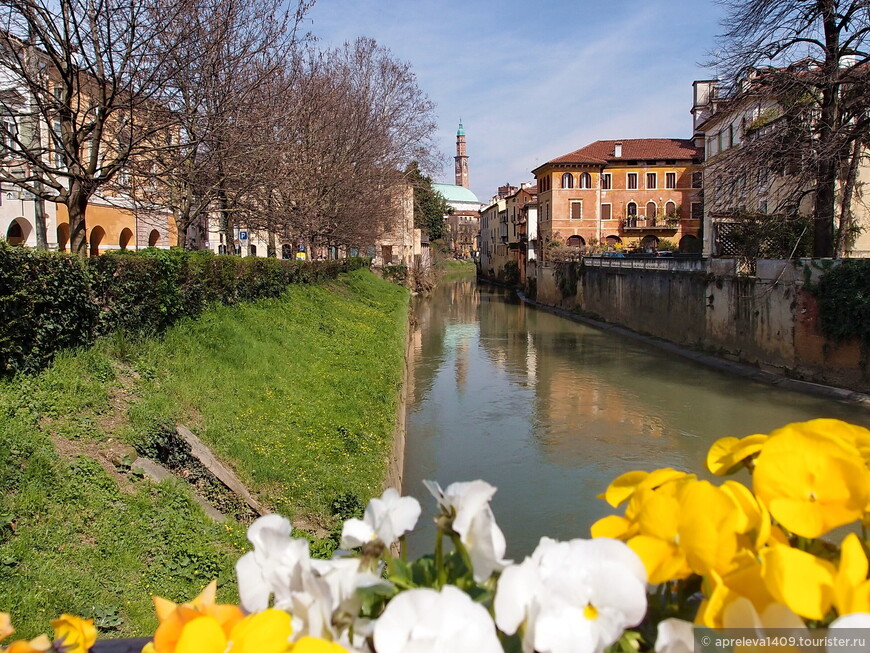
[495,538,646,653]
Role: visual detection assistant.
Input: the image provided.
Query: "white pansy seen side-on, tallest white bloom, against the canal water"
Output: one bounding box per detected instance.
[423,481,510,582]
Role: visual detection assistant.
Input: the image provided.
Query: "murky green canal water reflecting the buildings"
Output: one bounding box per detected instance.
[403,276,870,559]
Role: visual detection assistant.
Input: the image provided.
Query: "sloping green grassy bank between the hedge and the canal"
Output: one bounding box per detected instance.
[0,270,407,636]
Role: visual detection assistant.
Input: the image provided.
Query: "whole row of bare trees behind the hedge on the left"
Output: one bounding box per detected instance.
[0,0,436,255]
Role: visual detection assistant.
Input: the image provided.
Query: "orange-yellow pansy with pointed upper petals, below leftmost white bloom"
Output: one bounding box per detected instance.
[150,581,245,653]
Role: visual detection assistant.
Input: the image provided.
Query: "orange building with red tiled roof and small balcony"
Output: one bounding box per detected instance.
[532,138,703,265]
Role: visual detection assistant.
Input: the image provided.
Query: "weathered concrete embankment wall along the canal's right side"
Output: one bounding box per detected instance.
[537,259,870,392]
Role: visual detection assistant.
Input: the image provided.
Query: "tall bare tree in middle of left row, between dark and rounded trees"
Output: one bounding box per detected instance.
[124,0,313,250]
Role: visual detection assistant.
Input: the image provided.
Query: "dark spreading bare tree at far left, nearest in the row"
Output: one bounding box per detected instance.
[0,0,187,256]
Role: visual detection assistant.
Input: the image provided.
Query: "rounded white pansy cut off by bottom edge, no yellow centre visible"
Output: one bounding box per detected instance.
[374,585,502,653]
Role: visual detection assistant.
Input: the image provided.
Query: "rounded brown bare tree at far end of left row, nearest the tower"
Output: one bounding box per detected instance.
[270,39,435,258]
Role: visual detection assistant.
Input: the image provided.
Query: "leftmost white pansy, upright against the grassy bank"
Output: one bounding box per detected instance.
[236,515,310,613]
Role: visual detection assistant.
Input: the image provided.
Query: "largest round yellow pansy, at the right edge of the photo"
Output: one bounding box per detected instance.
[752,420,870,537]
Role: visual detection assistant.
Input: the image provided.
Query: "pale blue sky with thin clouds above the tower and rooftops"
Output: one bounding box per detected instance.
[306,0,721,202]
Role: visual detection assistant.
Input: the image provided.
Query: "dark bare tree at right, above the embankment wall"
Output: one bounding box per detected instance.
[711,0,870,257]
